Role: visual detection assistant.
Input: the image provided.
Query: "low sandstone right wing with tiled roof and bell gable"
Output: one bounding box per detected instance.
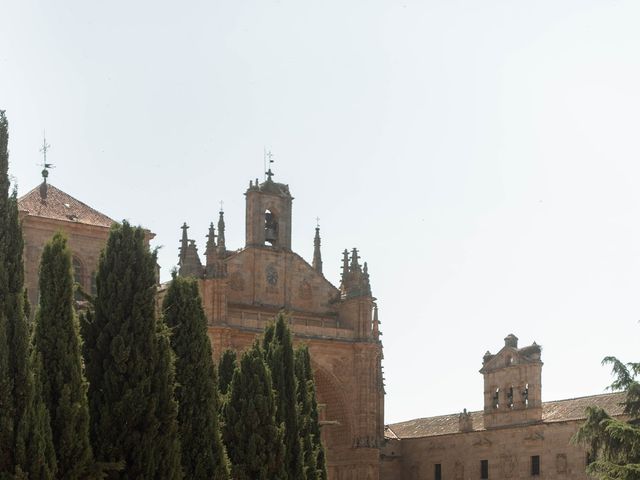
[380,335,622,480]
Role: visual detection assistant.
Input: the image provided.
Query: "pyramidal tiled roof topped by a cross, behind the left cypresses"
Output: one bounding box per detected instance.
[18,184,115,227]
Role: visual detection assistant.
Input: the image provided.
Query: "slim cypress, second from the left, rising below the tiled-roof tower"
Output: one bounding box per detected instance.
[35,233,93,480]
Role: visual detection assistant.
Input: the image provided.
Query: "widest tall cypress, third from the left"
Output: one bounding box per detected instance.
[83,222,182,480]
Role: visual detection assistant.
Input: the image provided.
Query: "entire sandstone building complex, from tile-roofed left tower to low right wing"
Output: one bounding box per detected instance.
[19,171,622,480]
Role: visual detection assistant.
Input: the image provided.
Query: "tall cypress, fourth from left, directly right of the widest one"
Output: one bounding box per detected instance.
[162,276,230,480]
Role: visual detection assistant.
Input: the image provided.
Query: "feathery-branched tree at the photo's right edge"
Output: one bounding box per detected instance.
[573,357,640,480]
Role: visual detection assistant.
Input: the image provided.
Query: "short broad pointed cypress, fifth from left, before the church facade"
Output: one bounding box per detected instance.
[222,341,288,480]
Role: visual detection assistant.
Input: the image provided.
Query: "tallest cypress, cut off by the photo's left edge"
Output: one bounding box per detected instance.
[0,111,56,480]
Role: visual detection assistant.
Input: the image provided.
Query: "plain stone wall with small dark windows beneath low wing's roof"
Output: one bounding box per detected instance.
[380,421,588,480]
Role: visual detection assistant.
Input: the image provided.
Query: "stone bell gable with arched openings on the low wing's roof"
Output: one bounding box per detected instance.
[480,334,543,428]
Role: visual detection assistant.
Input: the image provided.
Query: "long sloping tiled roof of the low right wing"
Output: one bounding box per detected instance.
[385,393,624,439]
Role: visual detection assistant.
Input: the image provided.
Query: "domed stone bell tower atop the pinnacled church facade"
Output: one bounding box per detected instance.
[245,169,293,250]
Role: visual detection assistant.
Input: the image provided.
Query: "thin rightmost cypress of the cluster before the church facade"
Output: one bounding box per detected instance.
[295,345,327,480]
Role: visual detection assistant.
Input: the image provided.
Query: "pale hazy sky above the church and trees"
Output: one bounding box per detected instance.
[0,0,640,422]
